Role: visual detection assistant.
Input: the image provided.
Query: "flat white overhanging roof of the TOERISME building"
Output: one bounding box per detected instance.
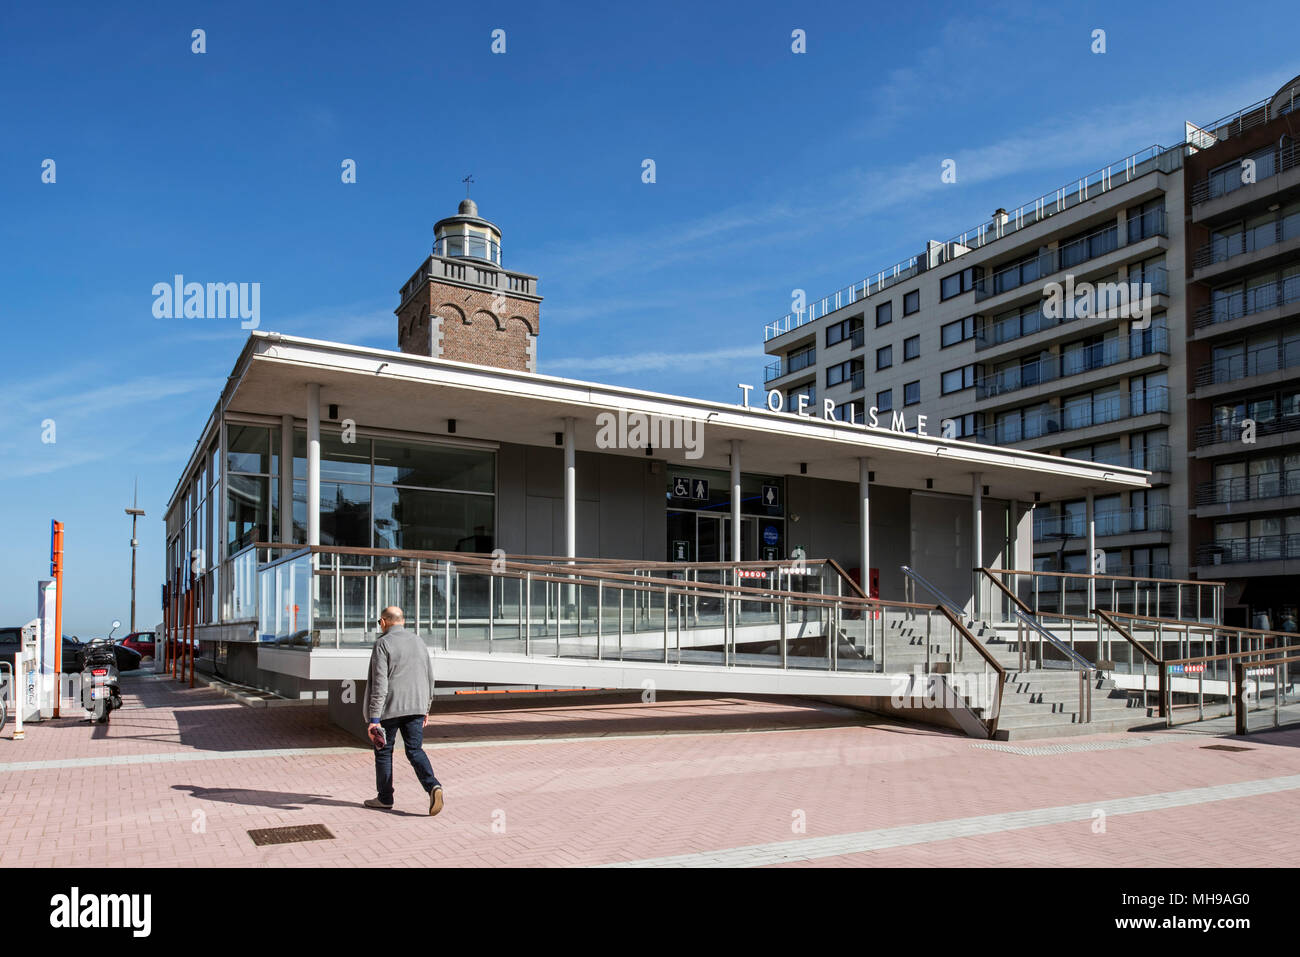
[165,332,1151,501]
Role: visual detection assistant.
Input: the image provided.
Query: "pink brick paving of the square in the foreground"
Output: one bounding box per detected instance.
[0,676,1300,866]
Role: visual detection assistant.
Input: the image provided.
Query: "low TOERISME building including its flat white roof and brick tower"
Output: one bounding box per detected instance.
[165,200,1151,696]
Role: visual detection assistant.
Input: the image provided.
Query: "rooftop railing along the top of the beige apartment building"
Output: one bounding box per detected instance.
[763,144,1183,342]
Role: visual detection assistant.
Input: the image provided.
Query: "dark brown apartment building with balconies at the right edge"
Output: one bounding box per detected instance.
[1184,81,1300,627]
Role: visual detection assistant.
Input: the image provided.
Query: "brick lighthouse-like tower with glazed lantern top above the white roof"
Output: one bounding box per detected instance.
[394,198,542,372]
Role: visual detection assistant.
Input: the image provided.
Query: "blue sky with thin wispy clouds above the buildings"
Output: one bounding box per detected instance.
[0,1,1300,637]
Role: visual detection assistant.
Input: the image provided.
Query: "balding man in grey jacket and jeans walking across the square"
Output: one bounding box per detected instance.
[365,605,442,814]
